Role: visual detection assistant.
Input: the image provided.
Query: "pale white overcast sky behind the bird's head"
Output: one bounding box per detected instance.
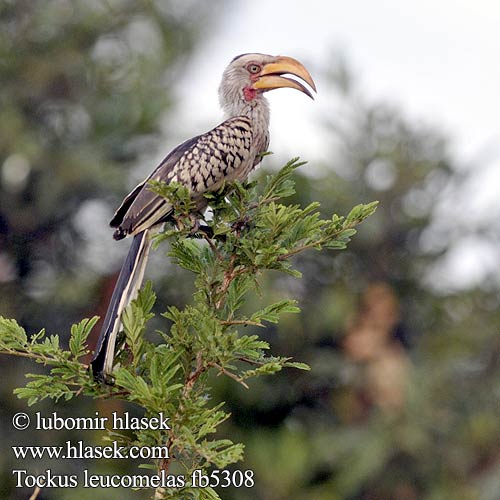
[167,0,500,292]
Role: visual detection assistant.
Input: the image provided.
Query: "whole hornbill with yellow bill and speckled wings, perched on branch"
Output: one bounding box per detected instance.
[91,54,316,381]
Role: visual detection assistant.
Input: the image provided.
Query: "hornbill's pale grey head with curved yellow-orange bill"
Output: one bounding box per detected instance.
[219,54,316,114]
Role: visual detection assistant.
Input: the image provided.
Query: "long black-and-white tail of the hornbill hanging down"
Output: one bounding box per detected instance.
[90,229,152,381]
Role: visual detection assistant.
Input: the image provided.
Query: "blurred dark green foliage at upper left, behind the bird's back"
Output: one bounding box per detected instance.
[0,0,218,329]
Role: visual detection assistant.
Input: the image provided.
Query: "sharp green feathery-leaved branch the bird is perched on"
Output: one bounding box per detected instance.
[0,160,376,499]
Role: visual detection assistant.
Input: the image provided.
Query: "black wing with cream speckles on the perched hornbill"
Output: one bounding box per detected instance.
[110,116,260,240]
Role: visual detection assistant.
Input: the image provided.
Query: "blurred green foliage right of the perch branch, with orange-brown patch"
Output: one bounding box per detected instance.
[220,60,500,500]
